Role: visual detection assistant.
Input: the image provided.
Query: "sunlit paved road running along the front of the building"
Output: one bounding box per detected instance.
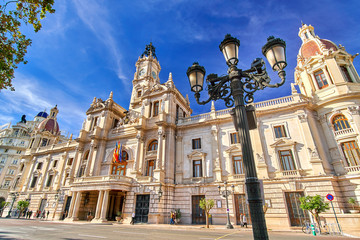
[0,218,354,240]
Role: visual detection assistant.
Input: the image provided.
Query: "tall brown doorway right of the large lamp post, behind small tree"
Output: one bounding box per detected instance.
[285,192,309,226]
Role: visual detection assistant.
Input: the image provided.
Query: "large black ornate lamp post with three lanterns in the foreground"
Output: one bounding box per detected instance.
[186,34,287,239]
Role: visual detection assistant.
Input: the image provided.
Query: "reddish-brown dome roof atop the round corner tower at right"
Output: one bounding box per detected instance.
[299,39,338,58]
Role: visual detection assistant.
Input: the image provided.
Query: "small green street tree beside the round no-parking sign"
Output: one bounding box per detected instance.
[300,195,330,232]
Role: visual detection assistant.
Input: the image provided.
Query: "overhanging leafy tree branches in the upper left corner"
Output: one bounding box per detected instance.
[0,0,55,91]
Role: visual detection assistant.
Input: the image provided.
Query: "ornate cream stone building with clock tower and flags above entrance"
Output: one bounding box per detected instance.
[3,25,360,231]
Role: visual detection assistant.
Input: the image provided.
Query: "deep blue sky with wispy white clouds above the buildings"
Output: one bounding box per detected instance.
[0,0,360,136]
